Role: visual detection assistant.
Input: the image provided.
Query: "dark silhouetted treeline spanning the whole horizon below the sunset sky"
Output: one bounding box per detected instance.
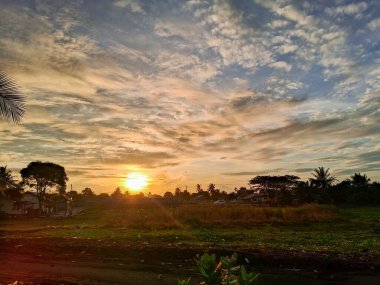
[0,161,380,208]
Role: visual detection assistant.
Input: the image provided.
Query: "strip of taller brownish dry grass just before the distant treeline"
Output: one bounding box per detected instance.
[96,204,337,229]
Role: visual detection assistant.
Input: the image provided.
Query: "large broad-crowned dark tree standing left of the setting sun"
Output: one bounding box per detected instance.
[20,161,68,213]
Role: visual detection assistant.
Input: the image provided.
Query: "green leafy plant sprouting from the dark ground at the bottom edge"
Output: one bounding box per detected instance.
[178,253,259,285]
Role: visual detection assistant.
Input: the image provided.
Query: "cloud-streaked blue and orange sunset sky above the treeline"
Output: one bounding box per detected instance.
[0,0,380,193]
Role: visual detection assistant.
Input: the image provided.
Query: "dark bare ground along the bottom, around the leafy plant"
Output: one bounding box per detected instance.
[0,238,380,285]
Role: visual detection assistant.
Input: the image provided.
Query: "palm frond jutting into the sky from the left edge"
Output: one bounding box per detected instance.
[0,72,25,123]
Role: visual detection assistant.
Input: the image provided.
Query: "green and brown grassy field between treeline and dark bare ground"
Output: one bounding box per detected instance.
[0,205,380,256]
